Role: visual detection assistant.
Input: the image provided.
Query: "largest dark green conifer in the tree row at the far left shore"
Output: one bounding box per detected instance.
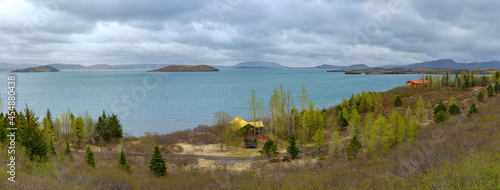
[15,106,48,161]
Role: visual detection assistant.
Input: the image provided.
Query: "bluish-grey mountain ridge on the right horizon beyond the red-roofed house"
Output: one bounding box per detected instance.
[404,59,500,70]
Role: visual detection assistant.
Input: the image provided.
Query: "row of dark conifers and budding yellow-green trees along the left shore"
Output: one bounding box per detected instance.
[0,106,123,161]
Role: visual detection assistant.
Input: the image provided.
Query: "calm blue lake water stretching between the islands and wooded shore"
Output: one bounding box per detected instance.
[0,68,418,136]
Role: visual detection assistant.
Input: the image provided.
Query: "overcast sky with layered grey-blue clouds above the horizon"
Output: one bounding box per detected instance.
[0,0,500,67]
